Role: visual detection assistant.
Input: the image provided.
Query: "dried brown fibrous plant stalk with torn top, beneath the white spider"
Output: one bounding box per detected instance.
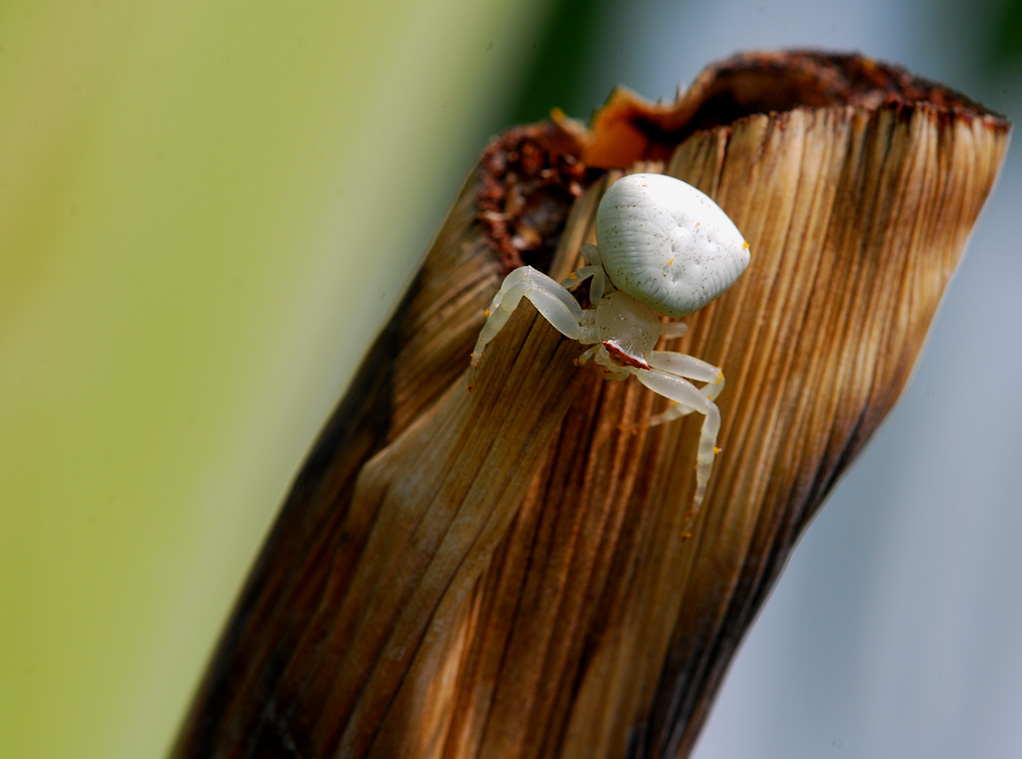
[176,52,1010,757]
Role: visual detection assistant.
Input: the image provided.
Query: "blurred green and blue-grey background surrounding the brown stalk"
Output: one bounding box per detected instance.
[0,0,1022,759]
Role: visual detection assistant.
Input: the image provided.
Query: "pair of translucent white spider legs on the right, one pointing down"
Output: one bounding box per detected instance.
[632,363,724,514]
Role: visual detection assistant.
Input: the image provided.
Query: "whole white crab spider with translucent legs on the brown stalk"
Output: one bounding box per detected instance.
[472,174,749,513]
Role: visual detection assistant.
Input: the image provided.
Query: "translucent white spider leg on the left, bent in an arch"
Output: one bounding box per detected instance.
[472,267,582,367]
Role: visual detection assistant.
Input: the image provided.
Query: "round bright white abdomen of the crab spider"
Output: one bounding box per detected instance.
[596,174,750,317]
